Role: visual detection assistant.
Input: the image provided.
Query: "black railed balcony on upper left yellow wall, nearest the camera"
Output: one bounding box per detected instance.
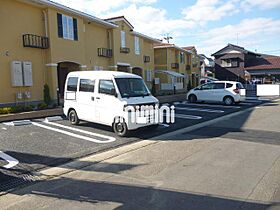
[22,34,49,49]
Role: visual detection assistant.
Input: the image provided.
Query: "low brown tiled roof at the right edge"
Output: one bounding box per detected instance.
[245,56,280,71]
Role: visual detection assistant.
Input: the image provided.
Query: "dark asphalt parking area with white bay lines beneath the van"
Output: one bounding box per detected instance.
[0,100,268,192]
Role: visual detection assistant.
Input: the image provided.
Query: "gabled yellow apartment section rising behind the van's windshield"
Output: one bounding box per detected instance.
[103,16,161,89]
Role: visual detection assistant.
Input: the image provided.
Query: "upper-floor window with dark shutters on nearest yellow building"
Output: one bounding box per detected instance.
[57,13,78,40]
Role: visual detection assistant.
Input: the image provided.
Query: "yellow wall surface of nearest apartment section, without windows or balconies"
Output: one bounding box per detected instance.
[0,0,115,105]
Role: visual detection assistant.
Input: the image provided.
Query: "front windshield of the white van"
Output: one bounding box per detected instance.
[115,78,151,98]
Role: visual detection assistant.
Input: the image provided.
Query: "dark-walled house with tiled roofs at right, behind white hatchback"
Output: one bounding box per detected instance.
[212,44,280,83]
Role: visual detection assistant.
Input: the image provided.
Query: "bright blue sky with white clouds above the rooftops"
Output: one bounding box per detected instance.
[53,0,280,56]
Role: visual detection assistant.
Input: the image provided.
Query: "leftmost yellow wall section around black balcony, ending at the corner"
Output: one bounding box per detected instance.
[0,0,48,104]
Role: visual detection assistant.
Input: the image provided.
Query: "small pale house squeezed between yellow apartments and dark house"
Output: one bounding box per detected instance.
[199,54,215,77]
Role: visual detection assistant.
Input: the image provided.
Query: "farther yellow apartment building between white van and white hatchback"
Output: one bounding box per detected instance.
[154,44,191,92]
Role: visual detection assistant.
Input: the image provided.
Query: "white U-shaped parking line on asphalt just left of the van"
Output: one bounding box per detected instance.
[32,122,116,144]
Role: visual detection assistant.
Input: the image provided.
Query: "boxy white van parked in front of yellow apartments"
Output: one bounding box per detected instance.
[63,71,159,136]
